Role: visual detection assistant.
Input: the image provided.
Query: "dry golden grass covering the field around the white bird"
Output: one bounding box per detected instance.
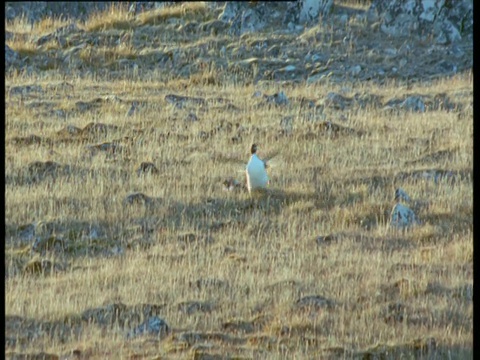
[5,3,473,359]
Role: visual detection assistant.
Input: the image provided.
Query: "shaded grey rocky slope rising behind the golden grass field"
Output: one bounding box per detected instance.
[5,0,473,83]
